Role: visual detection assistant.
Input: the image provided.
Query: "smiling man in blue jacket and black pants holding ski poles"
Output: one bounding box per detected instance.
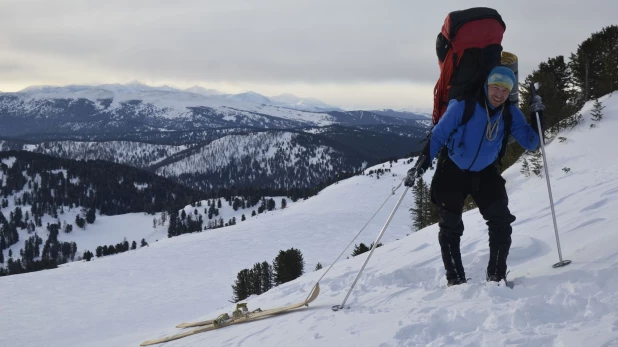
[405,66,544,286]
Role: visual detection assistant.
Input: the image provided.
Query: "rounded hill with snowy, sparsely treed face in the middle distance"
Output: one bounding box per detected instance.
[156,131,363,190]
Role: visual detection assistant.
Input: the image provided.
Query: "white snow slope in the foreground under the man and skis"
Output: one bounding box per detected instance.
[0,96,618,347]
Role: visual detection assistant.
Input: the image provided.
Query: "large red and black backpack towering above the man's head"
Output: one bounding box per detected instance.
[432,7,506,125]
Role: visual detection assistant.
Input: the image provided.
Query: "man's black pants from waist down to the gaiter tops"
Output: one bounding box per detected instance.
[431,153,515,247]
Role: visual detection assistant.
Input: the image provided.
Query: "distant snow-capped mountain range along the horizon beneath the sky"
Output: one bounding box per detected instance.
[0,82,429,138]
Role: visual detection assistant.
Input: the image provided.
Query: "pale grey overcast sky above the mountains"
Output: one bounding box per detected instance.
[0,0,618,110]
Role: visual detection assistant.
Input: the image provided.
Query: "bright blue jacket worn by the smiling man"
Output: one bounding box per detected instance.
[429,99,539,171]
